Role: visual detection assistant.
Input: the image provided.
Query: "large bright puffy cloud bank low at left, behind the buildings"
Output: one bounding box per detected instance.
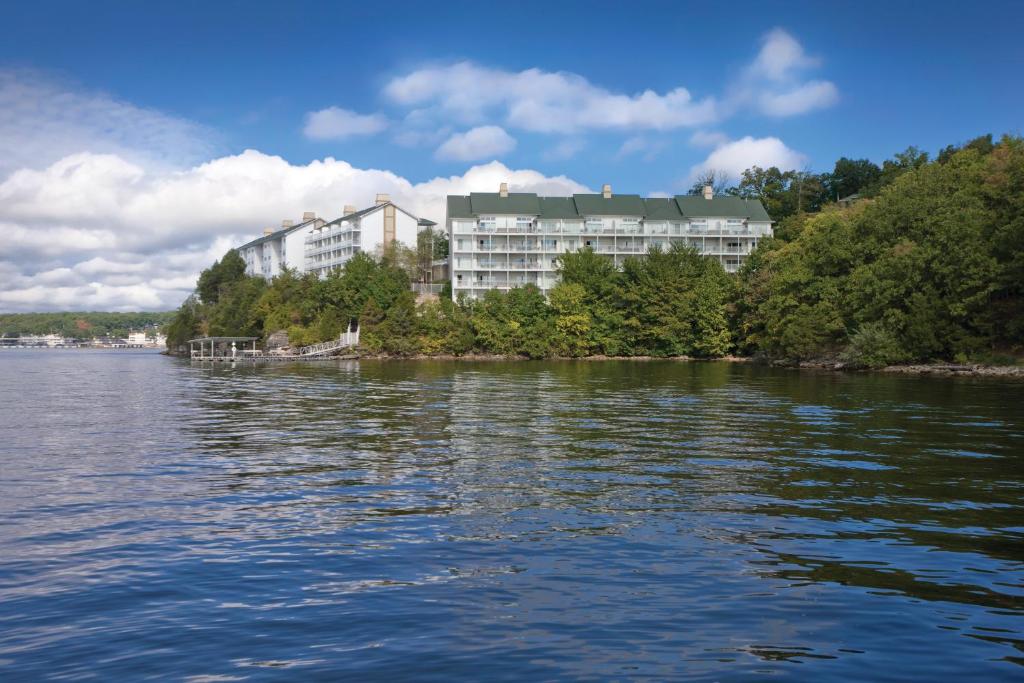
[0,151,587,311]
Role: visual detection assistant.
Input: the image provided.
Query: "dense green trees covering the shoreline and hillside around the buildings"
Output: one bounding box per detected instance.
[167,135,1024,368]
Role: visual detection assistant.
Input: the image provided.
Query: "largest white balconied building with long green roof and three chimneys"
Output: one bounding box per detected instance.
[446,182,772,298]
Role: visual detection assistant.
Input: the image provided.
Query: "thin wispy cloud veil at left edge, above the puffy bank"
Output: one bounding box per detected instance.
[0,69,218,176]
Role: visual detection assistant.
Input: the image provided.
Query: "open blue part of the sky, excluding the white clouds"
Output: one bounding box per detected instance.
[0,2,1024,187]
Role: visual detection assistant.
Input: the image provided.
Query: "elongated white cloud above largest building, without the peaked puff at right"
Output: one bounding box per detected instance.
[385,61,717,133]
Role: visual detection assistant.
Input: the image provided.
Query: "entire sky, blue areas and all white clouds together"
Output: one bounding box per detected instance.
[0,1,1024,309]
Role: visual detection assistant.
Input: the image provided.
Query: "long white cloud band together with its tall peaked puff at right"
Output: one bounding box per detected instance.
[384,29,839,140]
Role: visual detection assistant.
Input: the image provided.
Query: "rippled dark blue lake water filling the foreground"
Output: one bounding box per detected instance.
[0,351,1024,681]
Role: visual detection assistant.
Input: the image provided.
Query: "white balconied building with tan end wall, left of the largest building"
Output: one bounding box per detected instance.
[302,195,419,275]
